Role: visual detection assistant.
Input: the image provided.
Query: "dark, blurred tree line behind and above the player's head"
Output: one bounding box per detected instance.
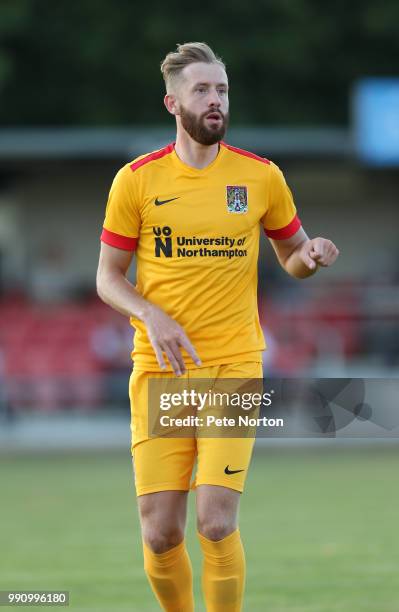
[0,0,399,126]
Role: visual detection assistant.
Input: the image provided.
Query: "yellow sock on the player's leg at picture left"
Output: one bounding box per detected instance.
[143,540,194,612]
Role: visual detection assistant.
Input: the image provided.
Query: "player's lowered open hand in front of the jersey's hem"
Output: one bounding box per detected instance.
[142,304,201,376]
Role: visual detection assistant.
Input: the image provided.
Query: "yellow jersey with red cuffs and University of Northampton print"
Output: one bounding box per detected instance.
[101,142,301,371]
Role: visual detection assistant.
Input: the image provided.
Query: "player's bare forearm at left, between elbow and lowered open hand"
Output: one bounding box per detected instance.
[97,272,151,321]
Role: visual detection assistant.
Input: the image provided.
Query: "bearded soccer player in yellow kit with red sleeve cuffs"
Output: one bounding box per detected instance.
[97,42,338,612]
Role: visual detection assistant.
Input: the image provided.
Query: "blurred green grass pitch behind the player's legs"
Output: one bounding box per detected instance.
[0,448,399,612]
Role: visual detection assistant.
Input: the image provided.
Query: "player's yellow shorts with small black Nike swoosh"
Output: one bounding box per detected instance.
[129,361,263,495]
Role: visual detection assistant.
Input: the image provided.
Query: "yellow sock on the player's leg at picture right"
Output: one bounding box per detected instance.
[198,529,245,612]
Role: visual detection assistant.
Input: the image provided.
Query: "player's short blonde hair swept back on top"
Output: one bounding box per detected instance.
[161,42,226,93]
